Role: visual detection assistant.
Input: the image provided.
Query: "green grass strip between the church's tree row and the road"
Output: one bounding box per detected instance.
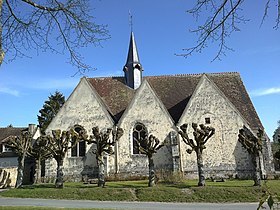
[0,180,280,202]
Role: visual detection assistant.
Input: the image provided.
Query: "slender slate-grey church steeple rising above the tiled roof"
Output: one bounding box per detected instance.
[123,32,143,89]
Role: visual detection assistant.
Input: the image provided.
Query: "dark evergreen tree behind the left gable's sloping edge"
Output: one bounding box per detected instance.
[37,91,65,133]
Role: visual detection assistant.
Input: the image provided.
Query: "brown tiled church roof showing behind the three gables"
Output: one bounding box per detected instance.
[87,72,263,128]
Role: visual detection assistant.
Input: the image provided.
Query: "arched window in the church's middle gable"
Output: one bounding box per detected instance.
[132,123,148,154]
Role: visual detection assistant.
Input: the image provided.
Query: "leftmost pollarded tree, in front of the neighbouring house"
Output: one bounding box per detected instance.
[5,131,32,188]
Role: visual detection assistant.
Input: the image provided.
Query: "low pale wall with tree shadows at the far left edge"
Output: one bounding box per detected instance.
[0,167,17,189]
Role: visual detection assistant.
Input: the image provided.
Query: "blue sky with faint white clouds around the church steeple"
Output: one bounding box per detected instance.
[0,0,280,137]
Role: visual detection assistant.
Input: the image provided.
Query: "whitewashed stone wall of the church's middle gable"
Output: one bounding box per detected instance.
[117,81,174,176]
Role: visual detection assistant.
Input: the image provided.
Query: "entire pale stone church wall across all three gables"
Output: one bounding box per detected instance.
[42,76,269,181]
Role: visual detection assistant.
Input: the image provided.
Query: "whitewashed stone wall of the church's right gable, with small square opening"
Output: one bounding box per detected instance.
[179,76,253,177]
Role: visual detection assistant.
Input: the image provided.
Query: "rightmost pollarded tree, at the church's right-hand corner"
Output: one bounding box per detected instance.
[238,125,263,186]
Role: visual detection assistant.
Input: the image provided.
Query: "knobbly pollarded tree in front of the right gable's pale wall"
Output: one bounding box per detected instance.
[179,123,215,186]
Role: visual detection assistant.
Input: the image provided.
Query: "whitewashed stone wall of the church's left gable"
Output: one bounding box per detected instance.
[46,78,115,181]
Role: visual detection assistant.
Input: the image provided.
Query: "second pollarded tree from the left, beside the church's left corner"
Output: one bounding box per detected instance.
[30,137,52,184]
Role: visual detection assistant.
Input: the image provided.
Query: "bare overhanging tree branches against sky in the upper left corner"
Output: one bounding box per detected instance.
[0,0,109,73]
